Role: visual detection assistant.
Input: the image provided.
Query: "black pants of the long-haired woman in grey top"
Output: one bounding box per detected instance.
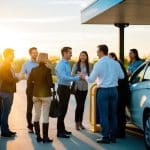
[75,90,87,123]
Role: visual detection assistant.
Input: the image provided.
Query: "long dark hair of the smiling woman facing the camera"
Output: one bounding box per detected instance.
[77,51,90,75]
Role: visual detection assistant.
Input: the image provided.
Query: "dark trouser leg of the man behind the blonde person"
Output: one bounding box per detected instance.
[26,88,33,128]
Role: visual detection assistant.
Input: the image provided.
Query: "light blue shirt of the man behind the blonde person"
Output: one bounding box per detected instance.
[21,60,38,79]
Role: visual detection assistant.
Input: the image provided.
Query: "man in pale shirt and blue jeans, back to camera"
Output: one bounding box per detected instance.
[83,45,124,143]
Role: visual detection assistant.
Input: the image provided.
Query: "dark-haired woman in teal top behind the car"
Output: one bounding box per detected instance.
[128,49,143,76]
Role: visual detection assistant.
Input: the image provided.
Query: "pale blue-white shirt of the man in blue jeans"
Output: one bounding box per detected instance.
[85,56,124,88]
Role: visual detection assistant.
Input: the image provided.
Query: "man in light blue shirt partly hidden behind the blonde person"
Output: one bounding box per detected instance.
[20,47,38,133]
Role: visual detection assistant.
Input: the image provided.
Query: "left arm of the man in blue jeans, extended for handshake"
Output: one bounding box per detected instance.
[85,64,100,83]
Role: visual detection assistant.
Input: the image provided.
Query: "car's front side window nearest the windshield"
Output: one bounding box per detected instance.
[130,64,146,84]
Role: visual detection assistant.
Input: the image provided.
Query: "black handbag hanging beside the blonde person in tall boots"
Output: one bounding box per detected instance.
[49,88,60,118]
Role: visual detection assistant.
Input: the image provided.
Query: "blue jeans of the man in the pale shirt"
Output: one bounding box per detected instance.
[97,87,118,137]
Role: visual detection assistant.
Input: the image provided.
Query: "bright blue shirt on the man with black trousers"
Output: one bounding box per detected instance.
[55,59,80,86]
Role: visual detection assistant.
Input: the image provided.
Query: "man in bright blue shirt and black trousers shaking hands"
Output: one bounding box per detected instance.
[56,47,80,138]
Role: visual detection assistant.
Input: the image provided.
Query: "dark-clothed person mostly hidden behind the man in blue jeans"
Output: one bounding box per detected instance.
[109,53,130,138]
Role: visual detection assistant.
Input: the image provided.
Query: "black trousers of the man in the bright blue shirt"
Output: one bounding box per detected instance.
[57,85,70,133]
